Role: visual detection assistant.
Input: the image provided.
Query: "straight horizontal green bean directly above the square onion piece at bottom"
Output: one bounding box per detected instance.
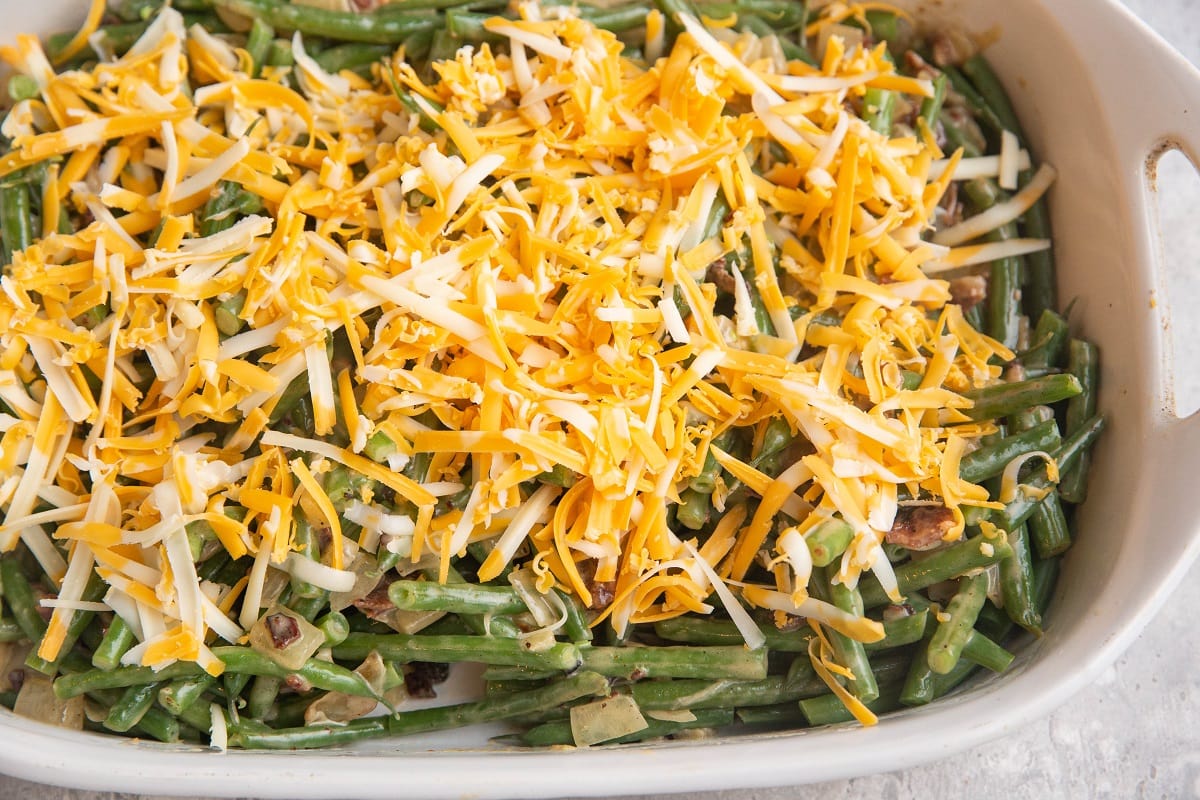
[580,645,767,680]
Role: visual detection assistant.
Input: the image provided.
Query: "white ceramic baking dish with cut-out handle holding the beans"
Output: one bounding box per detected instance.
[0,0,1200,799]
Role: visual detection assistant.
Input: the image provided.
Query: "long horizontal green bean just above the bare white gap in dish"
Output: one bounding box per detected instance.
[334,633,582,672]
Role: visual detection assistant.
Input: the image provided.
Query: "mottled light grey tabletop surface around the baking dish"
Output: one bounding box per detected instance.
[0,0,1200,800]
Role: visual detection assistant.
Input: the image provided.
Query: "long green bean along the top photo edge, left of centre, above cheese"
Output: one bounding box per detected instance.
[212,0,437,44]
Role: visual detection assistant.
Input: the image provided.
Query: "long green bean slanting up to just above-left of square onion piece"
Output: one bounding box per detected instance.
[229,672,608,750]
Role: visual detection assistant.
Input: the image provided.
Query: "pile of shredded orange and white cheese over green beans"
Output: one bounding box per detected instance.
[0,4,1045,674]
